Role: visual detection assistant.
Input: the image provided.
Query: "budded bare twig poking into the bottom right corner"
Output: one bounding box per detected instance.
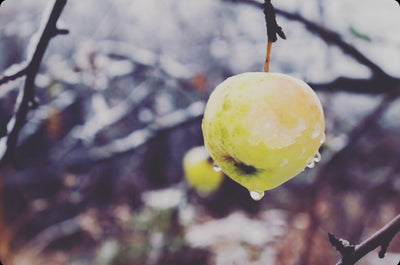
[329,214,400,265]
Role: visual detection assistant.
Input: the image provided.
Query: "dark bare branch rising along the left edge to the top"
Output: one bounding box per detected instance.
[0,0,68,164]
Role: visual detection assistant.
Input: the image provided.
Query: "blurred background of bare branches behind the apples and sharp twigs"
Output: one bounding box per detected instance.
[0,0,400,265]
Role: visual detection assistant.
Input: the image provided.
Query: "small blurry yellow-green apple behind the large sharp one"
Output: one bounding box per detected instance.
[182,146,224,195]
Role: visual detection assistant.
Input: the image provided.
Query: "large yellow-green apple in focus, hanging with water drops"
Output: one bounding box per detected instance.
[202,72,325,193]
